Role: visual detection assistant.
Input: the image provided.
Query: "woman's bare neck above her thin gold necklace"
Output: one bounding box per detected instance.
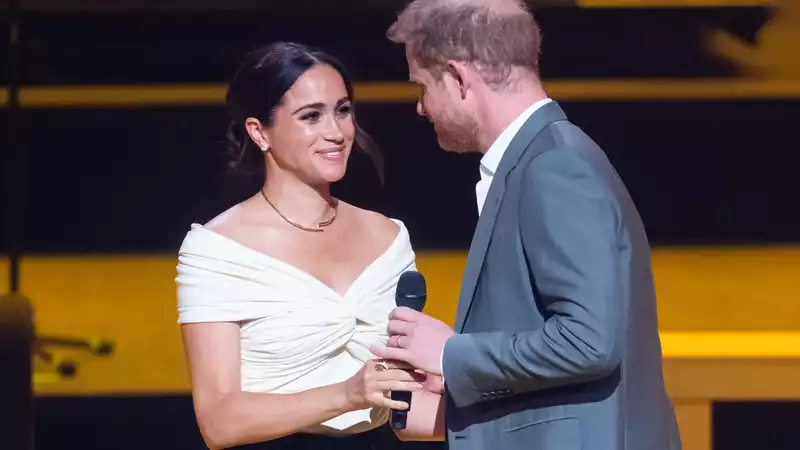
[262,171,335,227]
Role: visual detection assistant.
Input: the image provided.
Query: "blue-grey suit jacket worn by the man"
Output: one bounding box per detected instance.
[443,102,681,450]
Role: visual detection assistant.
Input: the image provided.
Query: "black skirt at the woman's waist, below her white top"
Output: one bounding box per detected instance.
[228,424,400,450]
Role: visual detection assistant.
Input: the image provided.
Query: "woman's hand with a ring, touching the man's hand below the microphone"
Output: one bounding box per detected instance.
[344,359,425,410]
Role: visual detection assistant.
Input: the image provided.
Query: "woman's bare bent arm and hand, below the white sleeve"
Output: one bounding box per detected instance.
[182,323,421,449]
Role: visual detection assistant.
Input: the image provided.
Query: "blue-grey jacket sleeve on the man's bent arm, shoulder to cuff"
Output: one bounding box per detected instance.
[443,149,624,406]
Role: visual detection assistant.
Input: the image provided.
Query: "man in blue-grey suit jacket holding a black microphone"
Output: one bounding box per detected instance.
[374,0,681,450]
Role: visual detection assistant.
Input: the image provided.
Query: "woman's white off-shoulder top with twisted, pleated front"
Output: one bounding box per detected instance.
[176,220,416,434]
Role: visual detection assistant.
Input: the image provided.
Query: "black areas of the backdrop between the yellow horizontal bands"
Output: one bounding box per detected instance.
[0,2,800,450]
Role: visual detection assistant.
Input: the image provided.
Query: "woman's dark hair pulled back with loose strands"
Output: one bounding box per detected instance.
[225,42,383,182]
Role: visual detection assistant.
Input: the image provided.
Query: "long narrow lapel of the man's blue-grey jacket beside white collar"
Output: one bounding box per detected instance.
[454,102,566,332]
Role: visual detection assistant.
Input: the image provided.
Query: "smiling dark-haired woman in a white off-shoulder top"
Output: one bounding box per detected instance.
[177,43,422,450]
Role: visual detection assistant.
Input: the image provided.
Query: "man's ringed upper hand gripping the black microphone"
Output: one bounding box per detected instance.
[371,306,454,375]
